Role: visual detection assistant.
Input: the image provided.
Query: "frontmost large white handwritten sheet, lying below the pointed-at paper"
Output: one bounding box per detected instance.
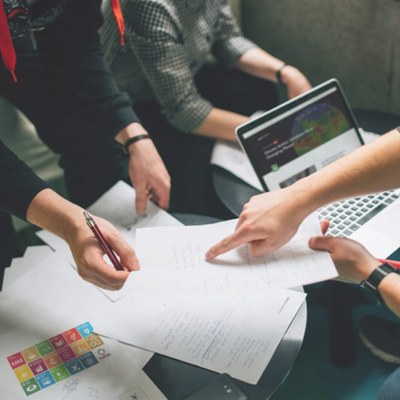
[96,289,305,384]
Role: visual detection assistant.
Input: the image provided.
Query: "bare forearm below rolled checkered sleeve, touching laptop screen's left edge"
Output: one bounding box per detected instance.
[193,108,249,142]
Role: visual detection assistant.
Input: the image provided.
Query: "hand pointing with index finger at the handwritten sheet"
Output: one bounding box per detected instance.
[206,187,308,260]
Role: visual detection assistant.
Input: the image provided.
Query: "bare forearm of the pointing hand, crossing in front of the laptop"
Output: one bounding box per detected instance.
[291,130,400,212]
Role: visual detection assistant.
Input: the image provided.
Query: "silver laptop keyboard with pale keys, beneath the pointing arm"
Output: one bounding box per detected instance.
[318,191,399,237]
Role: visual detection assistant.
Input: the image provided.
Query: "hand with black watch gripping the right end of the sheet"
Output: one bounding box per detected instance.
[309,221,381,283]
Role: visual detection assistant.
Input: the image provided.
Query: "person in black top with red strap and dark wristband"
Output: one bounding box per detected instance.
[0,0,170,272]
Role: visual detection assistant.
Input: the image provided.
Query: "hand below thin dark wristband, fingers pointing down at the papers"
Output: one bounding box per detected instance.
[129,139,171,214]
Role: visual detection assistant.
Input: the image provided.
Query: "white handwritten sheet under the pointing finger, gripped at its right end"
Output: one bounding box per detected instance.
[136,214,337,288]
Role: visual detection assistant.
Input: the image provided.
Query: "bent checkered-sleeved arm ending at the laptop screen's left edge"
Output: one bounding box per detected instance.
[120,0,248,141]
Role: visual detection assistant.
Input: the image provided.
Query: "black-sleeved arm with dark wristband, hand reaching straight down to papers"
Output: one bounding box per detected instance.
[40,0,170,214]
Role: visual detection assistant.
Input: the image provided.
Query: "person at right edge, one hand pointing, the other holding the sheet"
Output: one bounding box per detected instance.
[206,127,400,400]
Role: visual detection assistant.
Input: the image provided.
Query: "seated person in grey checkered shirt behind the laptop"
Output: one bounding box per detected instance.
[101,0,311,217]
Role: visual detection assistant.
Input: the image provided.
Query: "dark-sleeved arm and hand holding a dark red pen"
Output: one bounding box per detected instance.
[0,141,140,290]
